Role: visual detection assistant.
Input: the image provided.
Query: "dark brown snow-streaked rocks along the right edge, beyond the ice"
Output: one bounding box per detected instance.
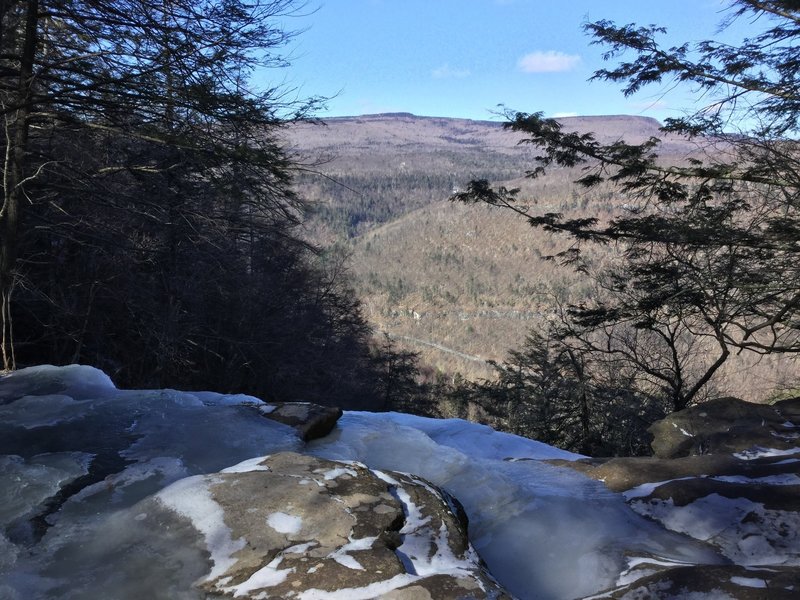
[557,398,800,599]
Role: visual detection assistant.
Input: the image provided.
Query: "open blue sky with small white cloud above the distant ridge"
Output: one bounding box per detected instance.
[271,0,764,119]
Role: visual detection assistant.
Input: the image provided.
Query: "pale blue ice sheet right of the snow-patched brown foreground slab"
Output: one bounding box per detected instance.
[309,413,722,599]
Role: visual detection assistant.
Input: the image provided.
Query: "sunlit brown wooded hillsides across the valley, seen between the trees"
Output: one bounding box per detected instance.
[287,114,796,400]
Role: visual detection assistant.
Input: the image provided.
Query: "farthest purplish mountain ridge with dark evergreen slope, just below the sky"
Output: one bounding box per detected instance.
[287,114,687,240]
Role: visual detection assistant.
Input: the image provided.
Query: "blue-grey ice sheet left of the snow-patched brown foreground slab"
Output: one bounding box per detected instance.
[0,366,303,600]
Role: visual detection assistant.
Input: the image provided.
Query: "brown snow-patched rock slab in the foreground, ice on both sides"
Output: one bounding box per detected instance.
[159,453,508,600]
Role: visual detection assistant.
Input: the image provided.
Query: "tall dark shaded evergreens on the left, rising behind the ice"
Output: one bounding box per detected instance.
[0,0,400,406]
